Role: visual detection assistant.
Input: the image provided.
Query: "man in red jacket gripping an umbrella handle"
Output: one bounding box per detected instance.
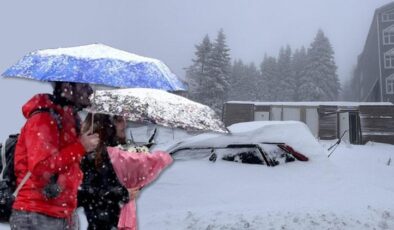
[10,82,99,230]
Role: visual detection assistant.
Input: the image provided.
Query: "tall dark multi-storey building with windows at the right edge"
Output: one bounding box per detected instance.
[353,2,394,102]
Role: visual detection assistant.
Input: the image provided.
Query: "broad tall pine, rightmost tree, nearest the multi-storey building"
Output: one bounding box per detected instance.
[300,30,340,101]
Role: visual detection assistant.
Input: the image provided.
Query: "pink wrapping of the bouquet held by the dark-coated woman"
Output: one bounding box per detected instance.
[107,147,172,230]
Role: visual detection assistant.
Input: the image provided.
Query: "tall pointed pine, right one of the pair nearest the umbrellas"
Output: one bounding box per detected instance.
[203,29,231,114]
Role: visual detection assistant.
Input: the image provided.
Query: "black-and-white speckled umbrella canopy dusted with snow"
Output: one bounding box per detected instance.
[90,88,226,132]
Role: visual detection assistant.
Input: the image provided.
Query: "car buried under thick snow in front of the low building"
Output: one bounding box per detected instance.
[167,121,324,166]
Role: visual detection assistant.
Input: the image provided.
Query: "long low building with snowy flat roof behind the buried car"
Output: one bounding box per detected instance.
[223,101,394,144]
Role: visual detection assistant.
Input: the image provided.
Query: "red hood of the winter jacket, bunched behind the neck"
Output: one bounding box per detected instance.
[22,94,57,118]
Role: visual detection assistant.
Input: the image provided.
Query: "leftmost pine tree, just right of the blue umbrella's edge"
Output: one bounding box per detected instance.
[186,35,212,101]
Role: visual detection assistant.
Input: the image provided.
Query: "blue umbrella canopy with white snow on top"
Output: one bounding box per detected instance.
[2,44,186,91]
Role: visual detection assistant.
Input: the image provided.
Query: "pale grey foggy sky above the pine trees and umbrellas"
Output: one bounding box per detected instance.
[0,0,391,139]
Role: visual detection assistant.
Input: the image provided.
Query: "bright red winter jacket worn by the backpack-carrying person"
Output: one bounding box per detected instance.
[13,94,85,218]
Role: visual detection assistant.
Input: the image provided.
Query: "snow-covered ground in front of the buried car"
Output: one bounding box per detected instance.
[0,124,394,230]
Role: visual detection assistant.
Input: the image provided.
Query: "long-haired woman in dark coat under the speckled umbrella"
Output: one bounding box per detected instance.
[78,114,129,230]
